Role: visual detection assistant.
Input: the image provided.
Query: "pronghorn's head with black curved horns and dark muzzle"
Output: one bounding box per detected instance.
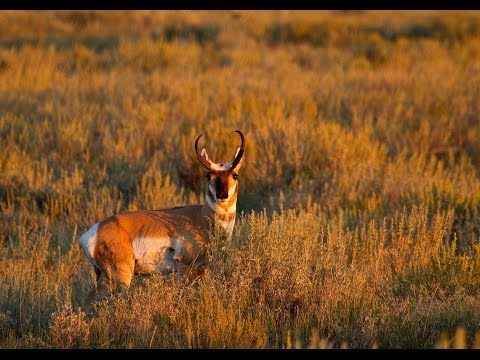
[195,130,245,203]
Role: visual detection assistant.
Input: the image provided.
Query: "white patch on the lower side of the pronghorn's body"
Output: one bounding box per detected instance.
[133,237,177,275]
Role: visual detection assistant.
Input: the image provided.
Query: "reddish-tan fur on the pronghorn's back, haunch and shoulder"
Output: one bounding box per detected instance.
[86,205,213,306]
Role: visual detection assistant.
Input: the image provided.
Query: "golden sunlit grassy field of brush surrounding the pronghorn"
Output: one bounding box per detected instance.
[0,11,480,348]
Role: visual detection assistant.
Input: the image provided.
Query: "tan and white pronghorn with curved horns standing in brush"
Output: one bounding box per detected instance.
[80,130,245,307]
